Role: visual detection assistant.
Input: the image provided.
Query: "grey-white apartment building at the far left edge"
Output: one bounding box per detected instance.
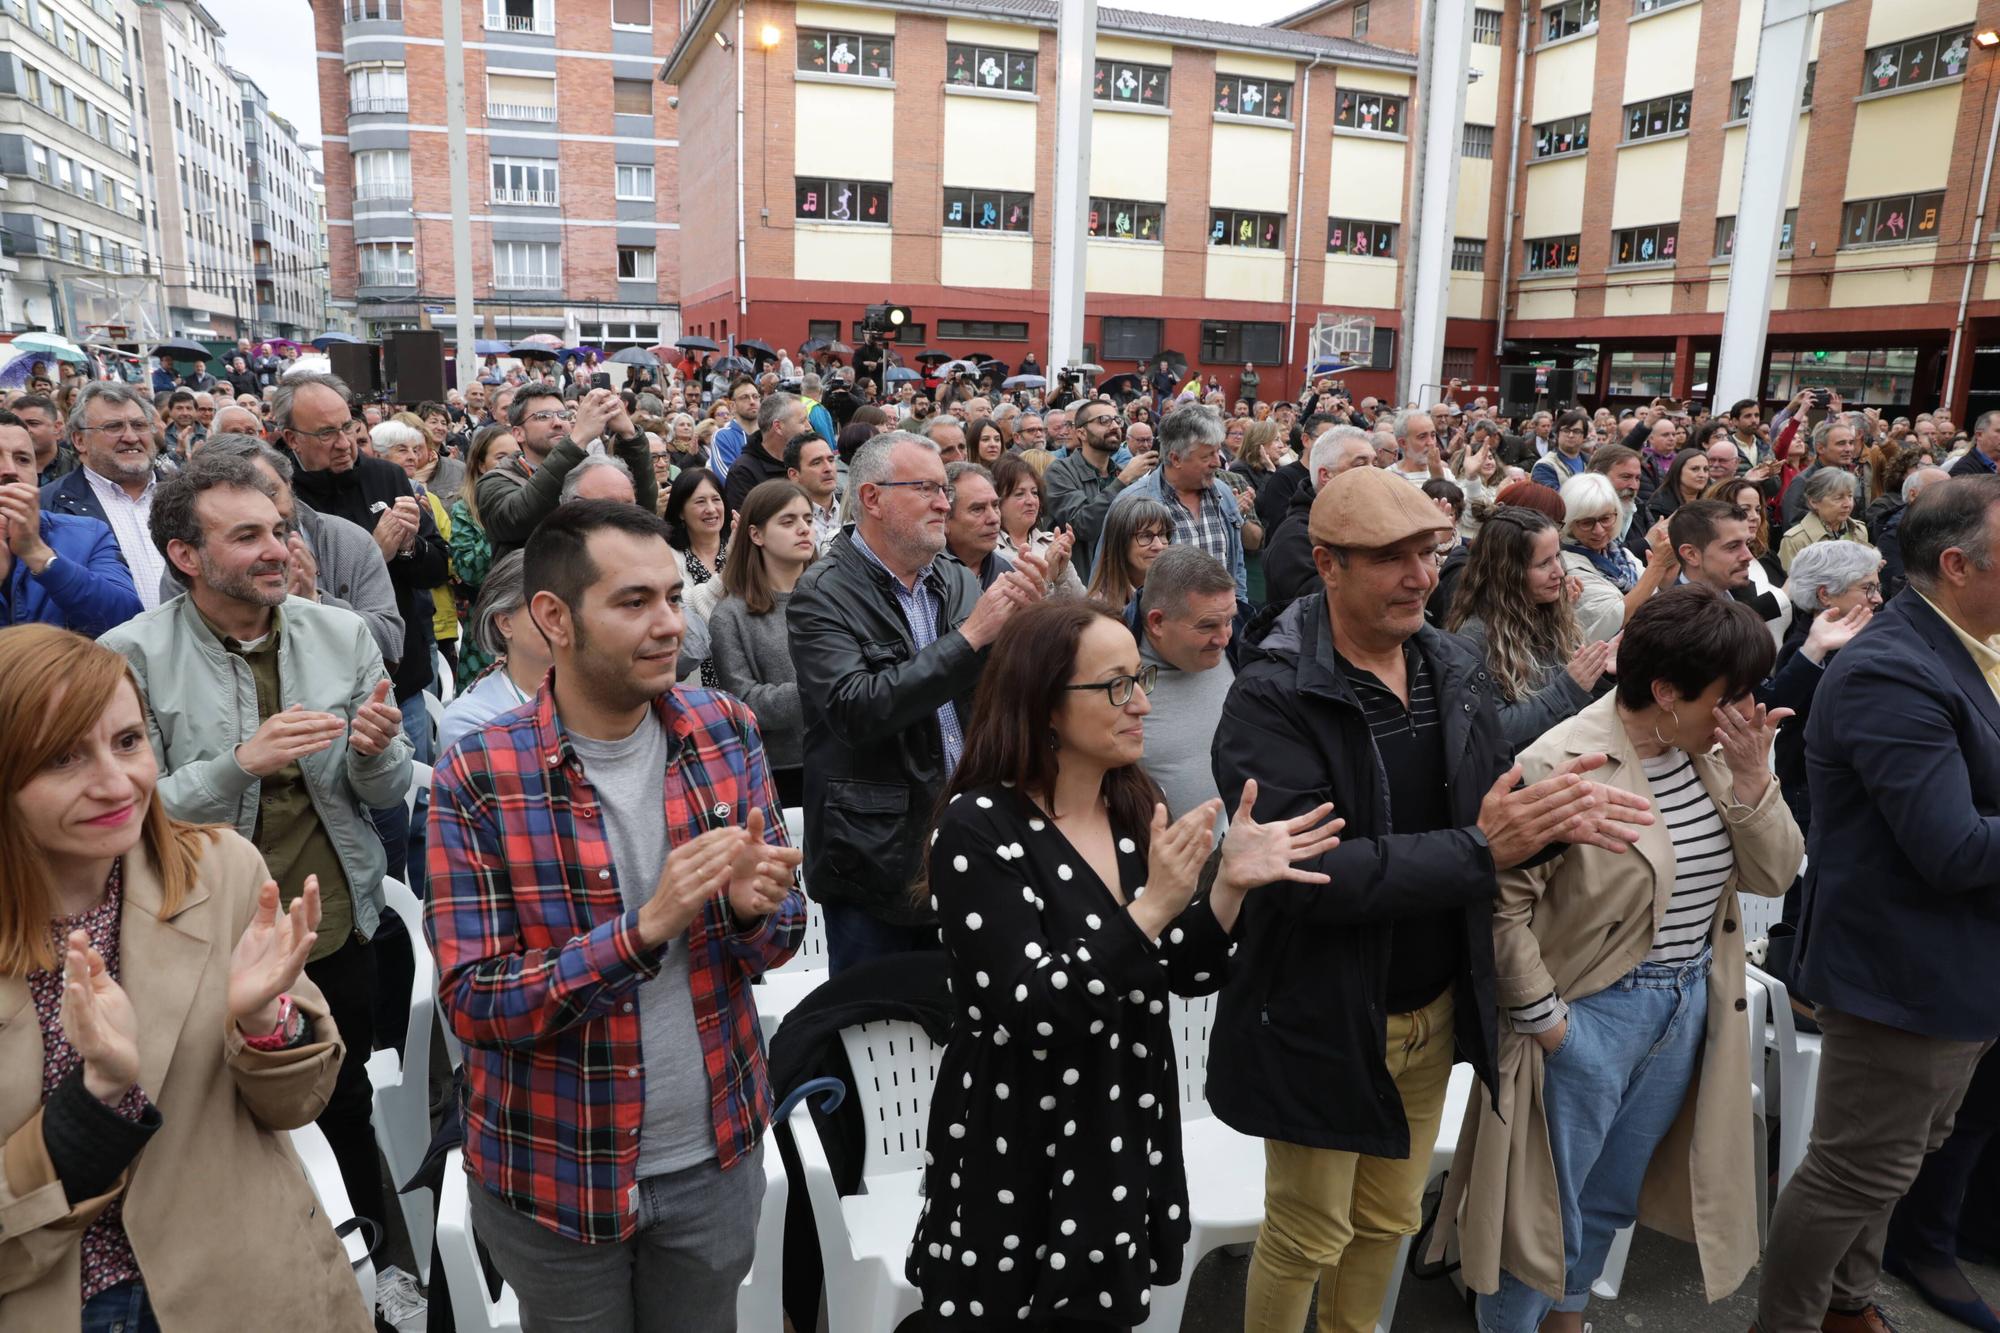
[0,0,168,340]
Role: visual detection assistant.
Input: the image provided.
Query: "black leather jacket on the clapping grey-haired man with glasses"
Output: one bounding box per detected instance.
[786,526,986,925]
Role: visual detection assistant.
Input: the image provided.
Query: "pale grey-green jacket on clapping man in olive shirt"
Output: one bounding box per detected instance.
[100,596,412,939]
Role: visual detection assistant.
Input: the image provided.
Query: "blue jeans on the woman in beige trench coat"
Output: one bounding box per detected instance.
[1478,953,1710,1333]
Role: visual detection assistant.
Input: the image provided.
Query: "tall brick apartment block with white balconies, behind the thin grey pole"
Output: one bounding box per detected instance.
[314,0,684,346]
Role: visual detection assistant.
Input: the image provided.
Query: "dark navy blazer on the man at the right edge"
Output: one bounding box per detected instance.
[1798,590,2000,1041]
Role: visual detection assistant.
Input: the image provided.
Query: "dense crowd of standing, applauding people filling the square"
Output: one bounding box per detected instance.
[0,334,2000,1333]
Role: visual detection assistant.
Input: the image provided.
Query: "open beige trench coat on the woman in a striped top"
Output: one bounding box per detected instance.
[1430,695,1804,1301]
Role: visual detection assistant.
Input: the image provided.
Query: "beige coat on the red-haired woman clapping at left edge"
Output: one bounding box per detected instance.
[0,829,374,1333]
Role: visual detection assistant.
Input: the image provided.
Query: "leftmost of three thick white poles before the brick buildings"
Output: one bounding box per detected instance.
[1042,0,1098,378]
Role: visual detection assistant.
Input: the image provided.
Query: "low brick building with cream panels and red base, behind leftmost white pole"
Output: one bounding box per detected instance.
[660,0,1424,396]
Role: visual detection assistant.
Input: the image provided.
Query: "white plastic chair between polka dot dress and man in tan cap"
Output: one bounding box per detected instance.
[1140,995,1264,1333]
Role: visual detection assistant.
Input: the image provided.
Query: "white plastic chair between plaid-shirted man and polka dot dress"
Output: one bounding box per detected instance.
[788,1021,944,1333]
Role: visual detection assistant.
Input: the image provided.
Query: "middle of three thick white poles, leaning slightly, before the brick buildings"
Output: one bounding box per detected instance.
[1396,0,1472,402]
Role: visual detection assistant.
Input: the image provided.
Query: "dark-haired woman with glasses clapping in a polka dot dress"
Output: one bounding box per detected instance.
[906,600,1340,1329]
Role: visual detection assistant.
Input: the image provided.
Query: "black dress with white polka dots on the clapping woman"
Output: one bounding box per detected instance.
[908,787,1228,1329]
